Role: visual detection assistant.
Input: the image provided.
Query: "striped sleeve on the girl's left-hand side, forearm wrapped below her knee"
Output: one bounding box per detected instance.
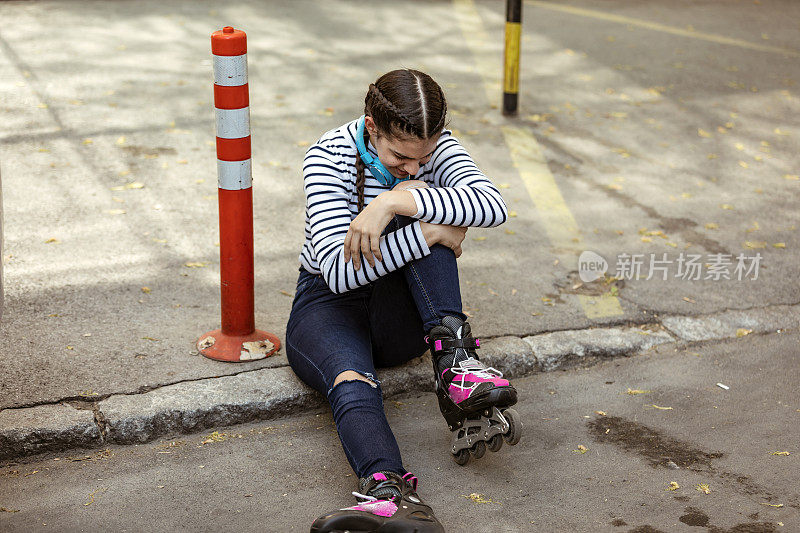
[301,144,431,294]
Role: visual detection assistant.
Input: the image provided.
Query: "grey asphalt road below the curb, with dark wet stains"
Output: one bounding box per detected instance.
[0,331,800,533]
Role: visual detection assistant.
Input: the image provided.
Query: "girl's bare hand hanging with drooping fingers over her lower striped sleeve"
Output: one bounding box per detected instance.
[344,195,394,270]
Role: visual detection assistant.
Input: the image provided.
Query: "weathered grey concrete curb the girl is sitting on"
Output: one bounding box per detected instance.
[0,305,800,459]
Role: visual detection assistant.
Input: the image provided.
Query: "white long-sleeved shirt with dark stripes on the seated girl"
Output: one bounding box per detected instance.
[300,120,508,294]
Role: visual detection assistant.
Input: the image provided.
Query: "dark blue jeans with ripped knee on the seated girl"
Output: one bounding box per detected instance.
[284,215,467,478]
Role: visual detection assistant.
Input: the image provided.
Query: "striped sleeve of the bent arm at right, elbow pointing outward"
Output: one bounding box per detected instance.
[410,134,508,228]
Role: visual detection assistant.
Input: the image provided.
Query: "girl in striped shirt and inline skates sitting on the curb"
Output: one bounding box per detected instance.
[285,69,516,533]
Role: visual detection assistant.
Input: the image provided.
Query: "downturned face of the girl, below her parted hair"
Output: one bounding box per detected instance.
[364,116,441,178]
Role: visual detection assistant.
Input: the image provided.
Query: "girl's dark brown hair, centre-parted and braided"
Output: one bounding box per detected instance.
[356,69,447,212]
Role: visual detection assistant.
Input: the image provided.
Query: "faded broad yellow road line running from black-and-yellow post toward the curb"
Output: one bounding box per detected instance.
[453,0,623,318]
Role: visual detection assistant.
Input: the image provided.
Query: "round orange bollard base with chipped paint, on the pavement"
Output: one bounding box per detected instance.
[197,329,281,363]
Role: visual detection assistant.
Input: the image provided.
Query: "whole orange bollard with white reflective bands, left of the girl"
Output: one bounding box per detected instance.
[197,26,280,362]
